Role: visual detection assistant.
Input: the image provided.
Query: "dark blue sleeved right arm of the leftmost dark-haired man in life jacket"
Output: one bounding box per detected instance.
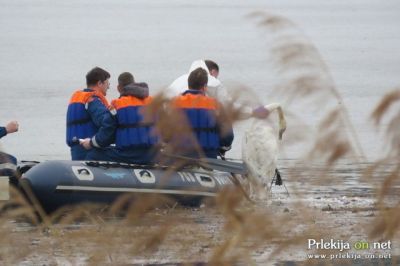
[82,97,116,148]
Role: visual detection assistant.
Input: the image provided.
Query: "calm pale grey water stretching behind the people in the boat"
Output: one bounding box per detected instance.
[0,0,400,160]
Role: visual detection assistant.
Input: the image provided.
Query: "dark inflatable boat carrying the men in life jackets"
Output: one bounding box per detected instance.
[19,160,241,212]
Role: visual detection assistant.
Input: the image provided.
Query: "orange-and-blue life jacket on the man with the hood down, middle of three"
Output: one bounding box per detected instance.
[111,96,158,149]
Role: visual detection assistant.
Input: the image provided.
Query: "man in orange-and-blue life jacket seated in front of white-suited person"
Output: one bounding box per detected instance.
[172,67,234,158]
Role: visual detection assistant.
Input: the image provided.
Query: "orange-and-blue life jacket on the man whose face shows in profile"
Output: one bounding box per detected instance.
[66,89,109,147]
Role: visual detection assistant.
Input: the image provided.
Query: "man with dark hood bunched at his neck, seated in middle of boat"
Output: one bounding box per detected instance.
[86,72,158,164]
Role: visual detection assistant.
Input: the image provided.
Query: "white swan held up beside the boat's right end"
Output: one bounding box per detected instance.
[242,103,286,198]
